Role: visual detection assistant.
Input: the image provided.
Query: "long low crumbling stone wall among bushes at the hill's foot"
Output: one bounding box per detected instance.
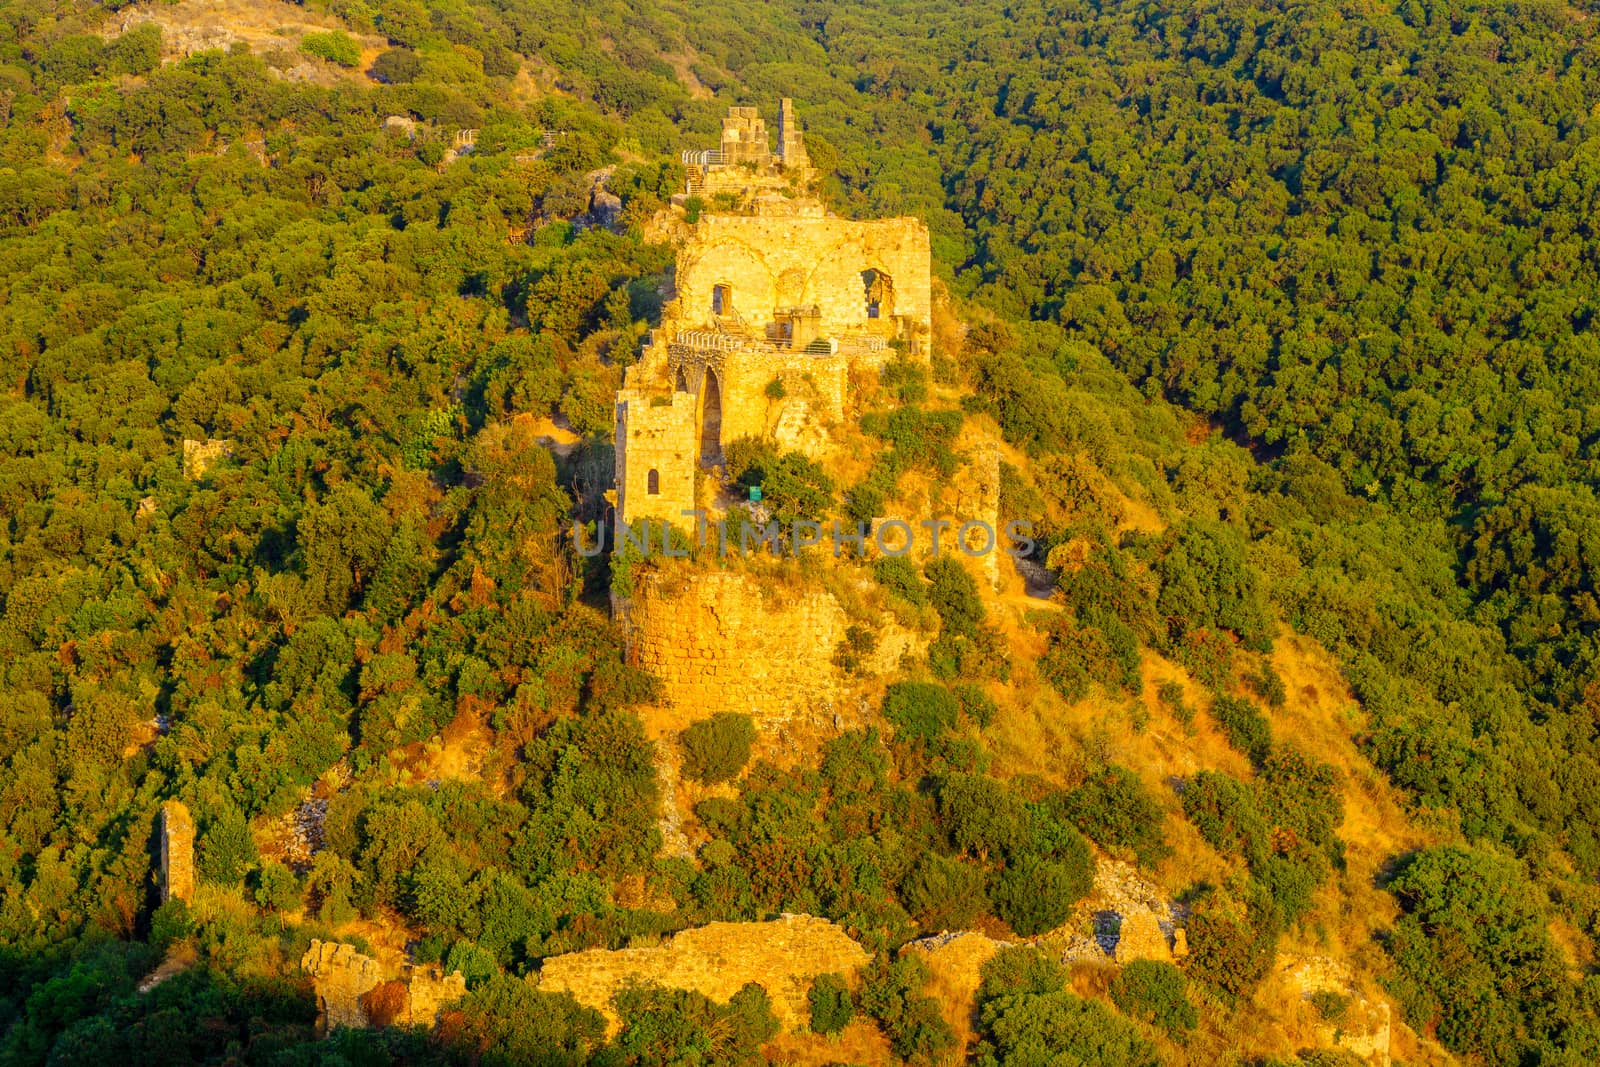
[538,915,870,1032]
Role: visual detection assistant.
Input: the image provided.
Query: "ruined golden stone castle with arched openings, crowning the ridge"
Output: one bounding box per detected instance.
[616,99,931,526]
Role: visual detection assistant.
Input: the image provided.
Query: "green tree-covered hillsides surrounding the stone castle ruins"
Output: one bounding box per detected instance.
[0,0,1600,1065]
